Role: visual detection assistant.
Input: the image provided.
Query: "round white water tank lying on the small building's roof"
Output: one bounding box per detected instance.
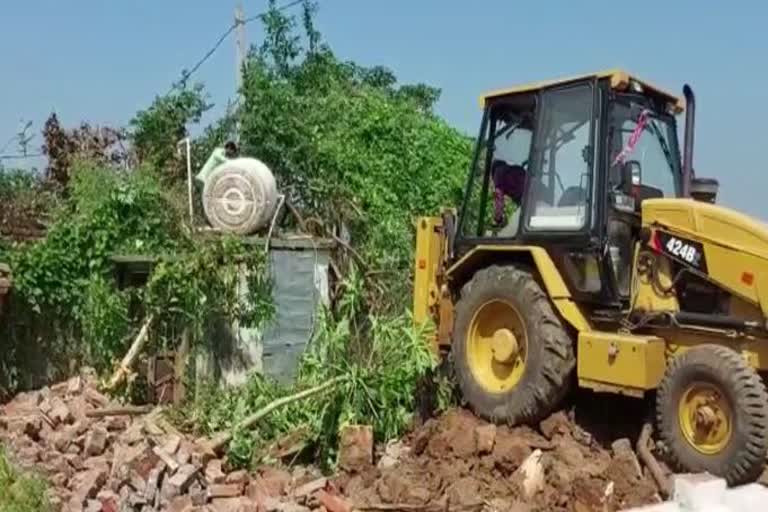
[203,158,278,235]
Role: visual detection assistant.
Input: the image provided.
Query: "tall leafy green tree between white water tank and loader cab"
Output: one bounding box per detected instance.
[240,2,470,309]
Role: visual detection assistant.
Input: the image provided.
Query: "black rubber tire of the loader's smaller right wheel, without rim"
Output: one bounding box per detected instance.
[656,345,768,485]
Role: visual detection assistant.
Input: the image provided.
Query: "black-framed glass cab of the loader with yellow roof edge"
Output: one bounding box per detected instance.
[454,73,683,309]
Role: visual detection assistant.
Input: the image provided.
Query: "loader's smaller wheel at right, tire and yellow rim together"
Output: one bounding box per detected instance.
[657,345,768,485]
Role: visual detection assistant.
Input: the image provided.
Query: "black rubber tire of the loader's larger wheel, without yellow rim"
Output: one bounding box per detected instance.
[452,265,576,425]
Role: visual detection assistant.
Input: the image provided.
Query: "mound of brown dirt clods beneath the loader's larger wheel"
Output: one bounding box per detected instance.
[337,410,661,511]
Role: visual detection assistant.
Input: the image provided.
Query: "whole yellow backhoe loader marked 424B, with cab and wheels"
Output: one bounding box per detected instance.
[414,70,768,485]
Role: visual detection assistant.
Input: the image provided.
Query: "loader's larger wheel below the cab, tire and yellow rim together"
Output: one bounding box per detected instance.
[452,266,575,424]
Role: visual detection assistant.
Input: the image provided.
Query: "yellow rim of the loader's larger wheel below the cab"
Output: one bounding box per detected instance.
[466,300,528,393]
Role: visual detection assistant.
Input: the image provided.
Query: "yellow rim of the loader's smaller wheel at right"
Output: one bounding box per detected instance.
[678,382,733,455]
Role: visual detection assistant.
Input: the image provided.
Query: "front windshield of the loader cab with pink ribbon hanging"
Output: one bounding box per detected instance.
[610,102,681,197]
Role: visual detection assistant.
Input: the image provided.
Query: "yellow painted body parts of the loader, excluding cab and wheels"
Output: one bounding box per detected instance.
[413,199,768,396]
